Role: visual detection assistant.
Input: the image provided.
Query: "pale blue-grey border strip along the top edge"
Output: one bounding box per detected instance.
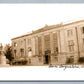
[0,0,84,4]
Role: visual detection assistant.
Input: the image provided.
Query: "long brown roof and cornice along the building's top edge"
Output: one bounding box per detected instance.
[11,20,84,40]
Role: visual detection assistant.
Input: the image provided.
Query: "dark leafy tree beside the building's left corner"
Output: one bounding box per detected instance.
[4,44,14,64]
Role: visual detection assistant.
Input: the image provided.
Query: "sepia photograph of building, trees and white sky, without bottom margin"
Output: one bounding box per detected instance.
[0,4,84,66]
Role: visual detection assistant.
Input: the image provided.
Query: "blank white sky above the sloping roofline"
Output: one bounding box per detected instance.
[0,3,84,45]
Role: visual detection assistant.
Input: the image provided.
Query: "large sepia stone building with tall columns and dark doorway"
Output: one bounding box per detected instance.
[11,20,84,65]
